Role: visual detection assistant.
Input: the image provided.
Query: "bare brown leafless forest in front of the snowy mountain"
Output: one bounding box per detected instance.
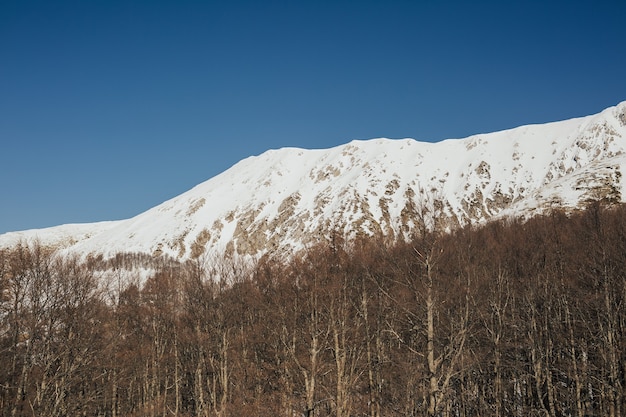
[0,205,626,417]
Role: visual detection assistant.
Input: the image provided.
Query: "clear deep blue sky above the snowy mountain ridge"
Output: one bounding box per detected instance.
[0,0,626,233]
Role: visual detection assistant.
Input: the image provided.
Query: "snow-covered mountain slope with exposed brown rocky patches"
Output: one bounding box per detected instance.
[0,102,626,259]
